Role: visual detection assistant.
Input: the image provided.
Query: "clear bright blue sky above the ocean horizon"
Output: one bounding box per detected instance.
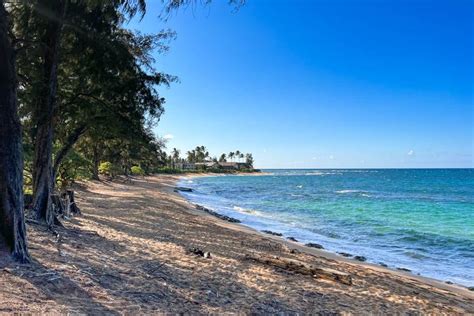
[129,0,474,168]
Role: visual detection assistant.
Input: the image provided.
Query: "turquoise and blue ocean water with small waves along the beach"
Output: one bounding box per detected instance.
[180,169,474,286]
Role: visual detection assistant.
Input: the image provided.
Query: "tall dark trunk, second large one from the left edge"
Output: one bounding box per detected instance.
[33,0,66,224]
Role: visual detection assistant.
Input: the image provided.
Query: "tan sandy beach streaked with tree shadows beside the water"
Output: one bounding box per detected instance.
[0,175,474,315]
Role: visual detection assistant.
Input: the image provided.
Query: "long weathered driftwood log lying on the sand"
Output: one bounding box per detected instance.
[245,255,352,285]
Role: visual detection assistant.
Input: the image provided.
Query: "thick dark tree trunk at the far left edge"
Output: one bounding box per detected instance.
[0,0,29,262]
